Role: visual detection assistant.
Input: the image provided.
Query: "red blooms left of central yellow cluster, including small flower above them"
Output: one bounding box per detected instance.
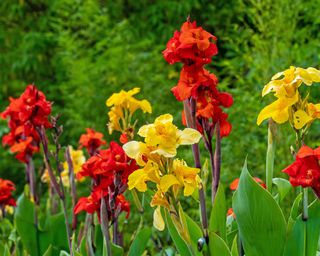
[74,129,138,219]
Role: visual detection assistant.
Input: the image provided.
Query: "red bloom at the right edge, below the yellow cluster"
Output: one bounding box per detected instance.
[283,146,320,198]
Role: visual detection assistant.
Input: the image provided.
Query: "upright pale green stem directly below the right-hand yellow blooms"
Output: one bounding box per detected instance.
[266,119,276,193]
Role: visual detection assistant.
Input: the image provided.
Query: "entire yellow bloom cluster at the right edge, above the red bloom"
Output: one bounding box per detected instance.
[257,66,320,130]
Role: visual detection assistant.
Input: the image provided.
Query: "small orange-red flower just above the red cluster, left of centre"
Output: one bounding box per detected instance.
[79,128,106,156]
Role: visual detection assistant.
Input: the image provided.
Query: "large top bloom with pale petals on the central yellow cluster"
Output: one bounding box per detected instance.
[138,114,201,157]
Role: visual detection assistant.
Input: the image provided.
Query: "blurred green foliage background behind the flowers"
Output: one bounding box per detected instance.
[0,0,320,197]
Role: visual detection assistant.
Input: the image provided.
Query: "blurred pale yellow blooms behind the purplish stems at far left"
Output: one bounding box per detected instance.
[41,146,86,187]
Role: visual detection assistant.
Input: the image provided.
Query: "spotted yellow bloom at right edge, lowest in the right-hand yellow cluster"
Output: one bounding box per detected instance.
[293,103,320,130]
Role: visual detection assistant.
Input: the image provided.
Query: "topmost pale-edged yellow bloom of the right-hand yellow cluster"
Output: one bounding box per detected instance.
[262,66,320,98]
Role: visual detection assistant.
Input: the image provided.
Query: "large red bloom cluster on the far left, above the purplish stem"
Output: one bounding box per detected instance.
[0,85,51,163]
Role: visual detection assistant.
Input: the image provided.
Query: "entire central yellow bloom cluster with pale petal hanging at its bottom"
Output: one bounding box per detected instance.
[123,114,201,230]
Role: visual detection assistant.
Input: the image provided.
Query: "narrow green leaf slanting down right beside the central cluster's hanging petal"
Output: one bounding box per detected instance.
[161,209,192,256]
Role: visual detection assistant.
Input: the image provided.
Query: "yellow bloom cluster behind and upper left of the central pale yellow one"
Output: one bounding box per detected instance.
[106,88,152,138]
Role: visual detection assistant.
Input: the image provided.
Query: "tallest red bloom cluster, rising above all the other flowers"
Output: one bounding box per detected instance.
[163,20,233,137]
